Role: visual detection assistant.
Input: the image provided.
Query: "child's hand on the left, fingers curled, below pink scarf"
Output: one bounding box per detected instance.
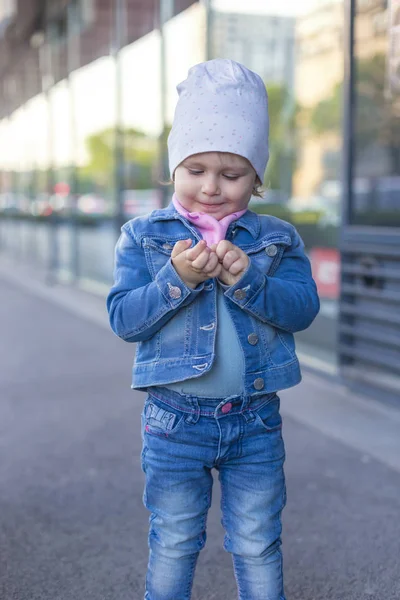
[171,239,222,289]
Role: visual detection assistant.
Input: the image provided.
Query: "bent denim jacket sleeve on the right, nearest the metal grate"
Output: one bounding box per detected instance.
[225,228,319,333]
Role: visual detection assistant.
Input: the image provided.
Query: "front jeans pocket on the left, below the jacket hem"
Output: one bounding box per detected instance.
[143,394,185,437]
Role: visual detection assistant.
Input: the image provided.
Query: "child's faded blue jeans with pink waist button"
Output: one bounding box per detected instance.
[142,388,286,600]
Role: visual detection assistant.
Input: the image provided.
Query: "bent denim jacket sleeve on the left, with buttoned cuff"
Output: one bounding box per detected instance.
[107,227,204,342]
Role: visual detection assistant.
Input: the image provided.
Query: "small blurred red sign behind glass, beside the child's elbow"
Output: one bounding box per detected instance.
[310,248,340,300]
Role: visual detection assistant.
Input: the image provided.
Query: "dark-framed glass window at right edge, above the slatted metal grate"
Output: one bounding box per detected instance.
[350,0,400,227]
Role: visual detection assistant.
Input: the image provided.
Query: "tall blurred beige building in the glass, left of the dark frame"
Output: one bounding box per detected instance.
[294,2,344,202]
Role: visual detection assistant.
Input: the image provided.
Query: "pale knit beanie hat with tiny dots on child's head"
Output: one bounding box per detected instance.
[168,58,269,182]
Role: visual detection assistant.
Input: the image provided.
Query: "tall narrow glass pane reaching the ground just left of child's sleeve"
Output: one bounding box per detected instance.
[70,0,119,285]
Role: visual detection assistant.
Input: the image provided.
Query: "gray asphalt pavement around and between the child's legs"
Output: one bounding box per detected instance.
[0,260,400,600]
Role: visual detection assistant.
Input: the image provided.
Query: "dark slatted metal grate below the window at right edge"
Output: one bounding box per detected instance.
[338,227,400,405]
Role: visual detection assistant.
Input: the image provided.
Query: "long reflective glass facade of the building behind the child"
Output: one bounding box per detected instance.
[0,0,400,365]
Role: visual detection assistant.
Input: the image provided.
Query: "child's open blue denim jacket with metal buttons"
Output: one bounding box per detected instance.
[107,204,319,396]
